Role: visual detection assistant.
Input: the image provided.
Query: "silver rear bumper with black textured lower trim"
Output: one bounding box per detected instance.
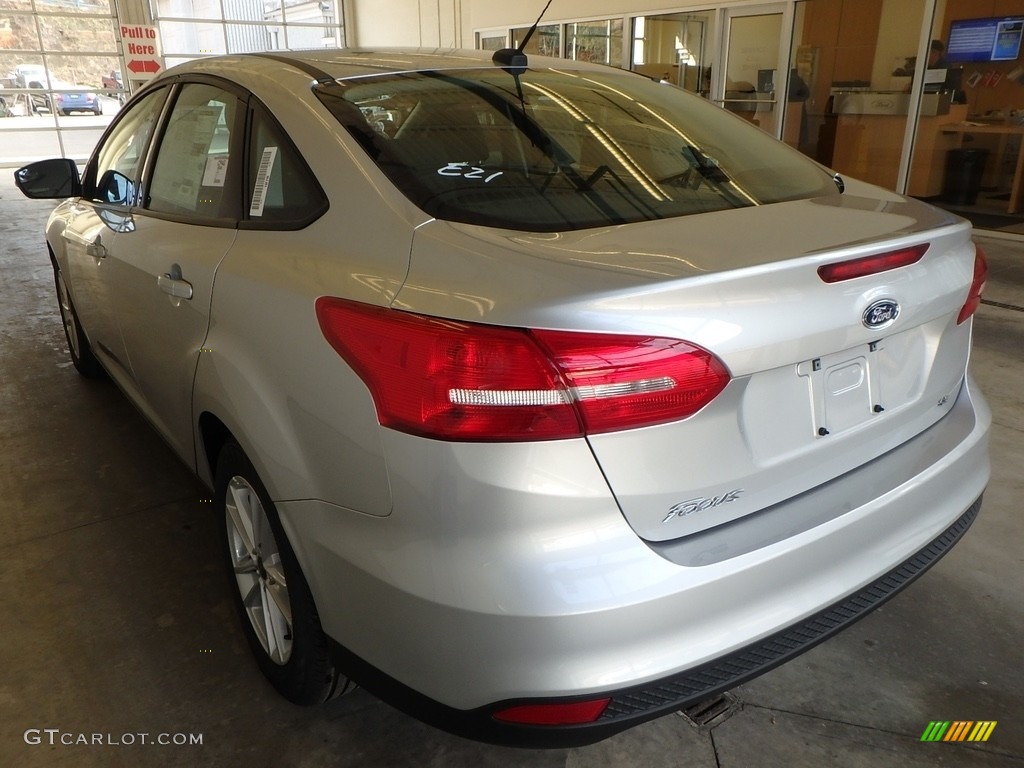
[278,381,990,746]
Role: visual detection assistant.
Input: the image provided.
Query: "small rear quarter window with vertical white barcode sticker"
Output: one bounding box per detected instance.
[245,105,328,229]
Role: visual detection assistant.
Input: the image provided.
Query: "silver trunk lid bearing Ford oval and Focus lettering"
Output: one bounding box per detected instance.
[396,188,975,541]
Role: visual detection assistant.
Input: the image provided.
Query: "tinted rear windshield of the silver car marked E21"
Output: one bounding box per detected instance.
[316,67,839,231]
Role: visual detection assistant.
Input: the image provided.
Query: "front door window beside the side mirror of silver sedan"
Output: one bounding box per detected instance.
[82,88,168,207]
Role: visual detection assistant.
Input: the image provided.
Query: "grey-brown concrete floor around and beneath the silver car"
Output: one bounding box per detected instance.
[0,170,1024,768]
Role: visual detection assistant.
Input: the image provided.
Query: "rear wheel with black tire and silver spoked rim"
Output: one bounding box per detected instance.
[215,440,349,705]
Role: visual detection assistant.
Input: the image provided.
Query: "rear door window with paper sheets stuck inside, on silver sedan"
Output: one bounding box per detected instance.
[146,83,244,220]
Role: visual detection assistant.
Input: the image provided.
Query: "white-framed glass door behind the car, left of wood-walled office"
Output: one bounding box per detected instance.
[715,3,799,137]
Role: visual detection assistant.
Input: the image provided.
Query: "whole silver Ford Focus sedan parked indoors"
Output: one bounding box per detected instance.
[15,50,990,745]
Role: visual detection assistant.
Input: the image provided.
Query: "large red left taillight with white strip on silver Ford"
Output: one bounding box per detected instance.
[316,297,729,441]
